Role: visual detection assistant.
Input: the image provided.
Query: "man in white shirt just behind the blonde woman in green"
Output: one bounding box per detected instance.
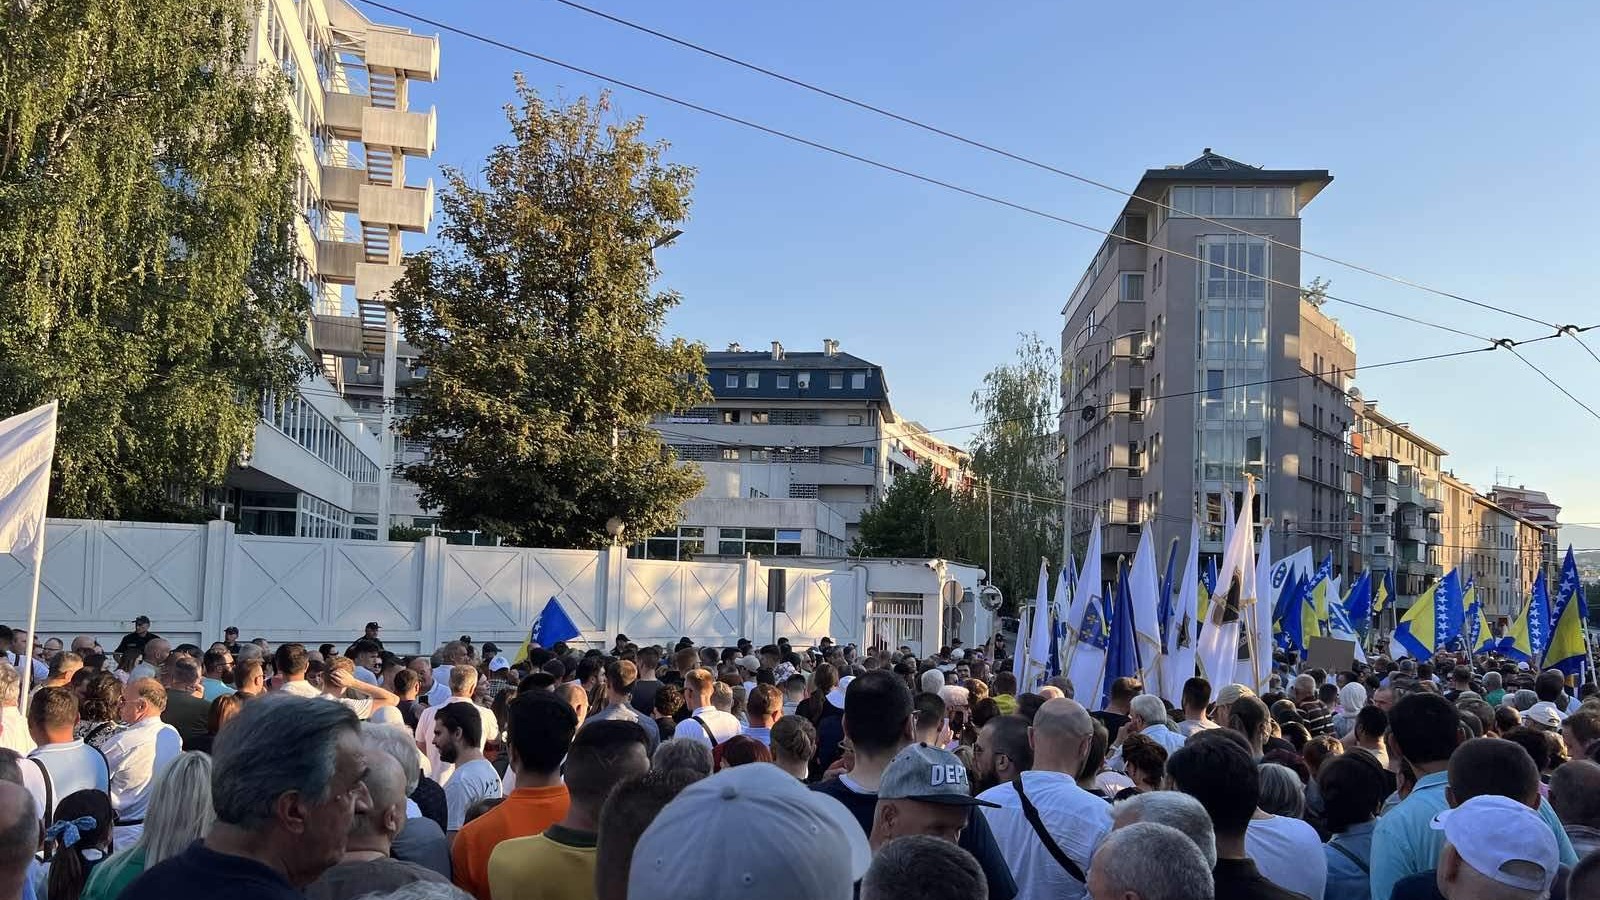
[101,677,182,847]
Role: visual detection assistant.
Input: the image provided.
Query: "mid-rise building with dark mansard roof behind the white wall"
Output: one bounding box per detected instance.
[638,340,966,559]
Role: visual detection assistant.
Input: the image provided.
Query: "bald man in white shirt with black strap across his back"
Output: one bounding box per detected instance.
[978,700,1110,900]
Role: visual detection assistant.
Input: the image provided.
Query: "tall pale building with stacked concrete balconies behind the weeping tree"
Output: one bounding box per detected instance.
[227,0,438,538]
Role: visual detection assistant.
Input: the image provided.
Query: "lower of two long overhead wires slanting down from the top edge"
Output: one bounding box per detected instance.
[360,0,1510,343]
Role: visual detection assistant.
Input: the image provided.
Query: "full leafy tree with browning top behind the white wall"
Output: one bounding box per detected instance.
[394,85,710,548]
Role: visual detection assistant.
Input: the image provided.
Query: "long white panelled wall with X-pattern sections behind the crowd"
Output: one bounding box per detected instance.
[0,519,876,650]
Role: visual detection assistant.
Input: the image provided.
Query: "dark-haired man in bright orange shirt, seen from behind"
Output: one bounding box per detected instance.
[450,692,578,900]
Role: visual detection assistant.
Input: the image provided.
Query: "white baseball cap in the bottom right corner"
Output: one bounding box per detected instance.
[1434,794,1562,890]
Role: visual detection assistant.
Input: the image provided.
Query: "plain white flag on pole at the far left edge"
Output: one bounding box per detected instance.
[0,400,56,557]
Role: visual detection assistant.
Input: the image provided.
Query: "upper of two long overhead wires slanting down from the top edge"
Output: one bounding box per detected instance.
[555,0,1561,329]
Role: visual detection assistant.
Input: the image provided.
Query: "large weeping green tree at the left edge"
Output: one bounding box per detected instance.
[0,0,309,519]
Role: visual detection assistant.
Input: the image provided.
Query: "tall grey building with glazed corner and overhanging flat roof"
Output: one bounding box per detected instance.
[1061,149,1355,557]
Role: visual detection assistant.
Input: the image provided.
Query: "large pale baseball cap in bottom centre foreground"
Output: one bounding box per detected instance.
[627,762,872,900]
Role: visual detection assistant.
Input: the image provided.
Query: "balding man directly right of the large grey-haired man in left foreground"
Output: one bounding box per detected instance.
[306,753,450,900]
